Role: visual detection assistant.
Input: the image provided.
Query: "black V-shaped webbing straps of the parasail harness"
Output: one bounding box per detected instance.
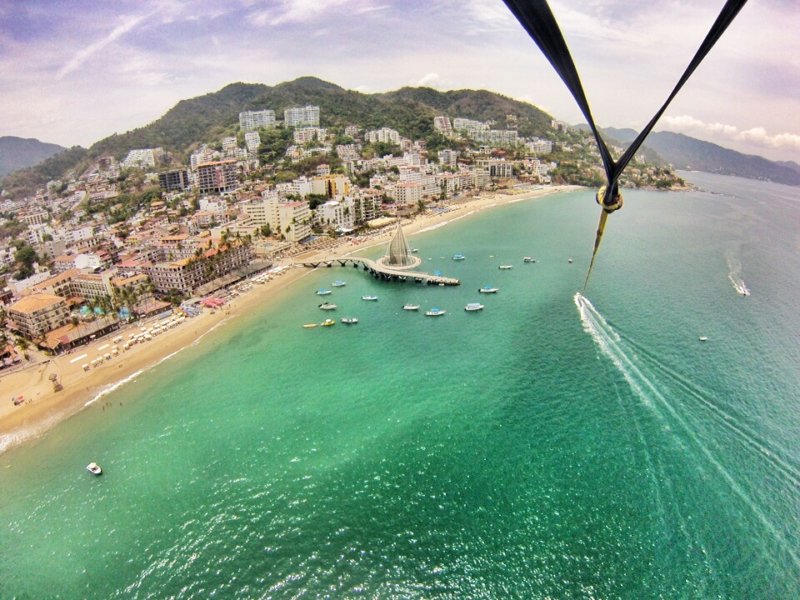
[503,0,747,205]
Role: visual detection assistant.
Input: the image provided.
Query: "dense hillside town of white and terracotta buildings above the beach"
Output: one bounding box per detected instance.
[0,106,674,367]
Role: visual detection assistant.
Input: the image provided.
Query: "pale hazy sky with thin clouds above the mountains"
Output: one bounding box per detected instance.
[0,0,800,163]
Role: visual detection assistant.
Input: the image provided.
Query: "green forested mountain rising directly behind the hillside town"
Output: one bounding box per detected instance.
[3,77,551,197]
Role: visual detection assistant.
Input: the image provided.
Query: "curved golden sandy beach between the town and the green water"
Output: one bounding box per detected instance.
[0,186,578,452]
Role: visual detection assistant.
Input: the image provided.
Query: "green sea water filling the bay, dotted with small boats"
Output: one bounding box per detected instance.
[0,173,800,599]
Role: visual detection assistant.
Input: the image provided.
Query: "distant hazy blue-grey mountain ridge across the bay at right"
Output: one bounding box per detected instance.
[603,127,800,185]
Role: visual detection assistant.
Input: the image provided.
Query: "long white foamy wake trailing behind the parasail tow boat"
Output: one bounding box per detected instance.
[574,292,800,568]
